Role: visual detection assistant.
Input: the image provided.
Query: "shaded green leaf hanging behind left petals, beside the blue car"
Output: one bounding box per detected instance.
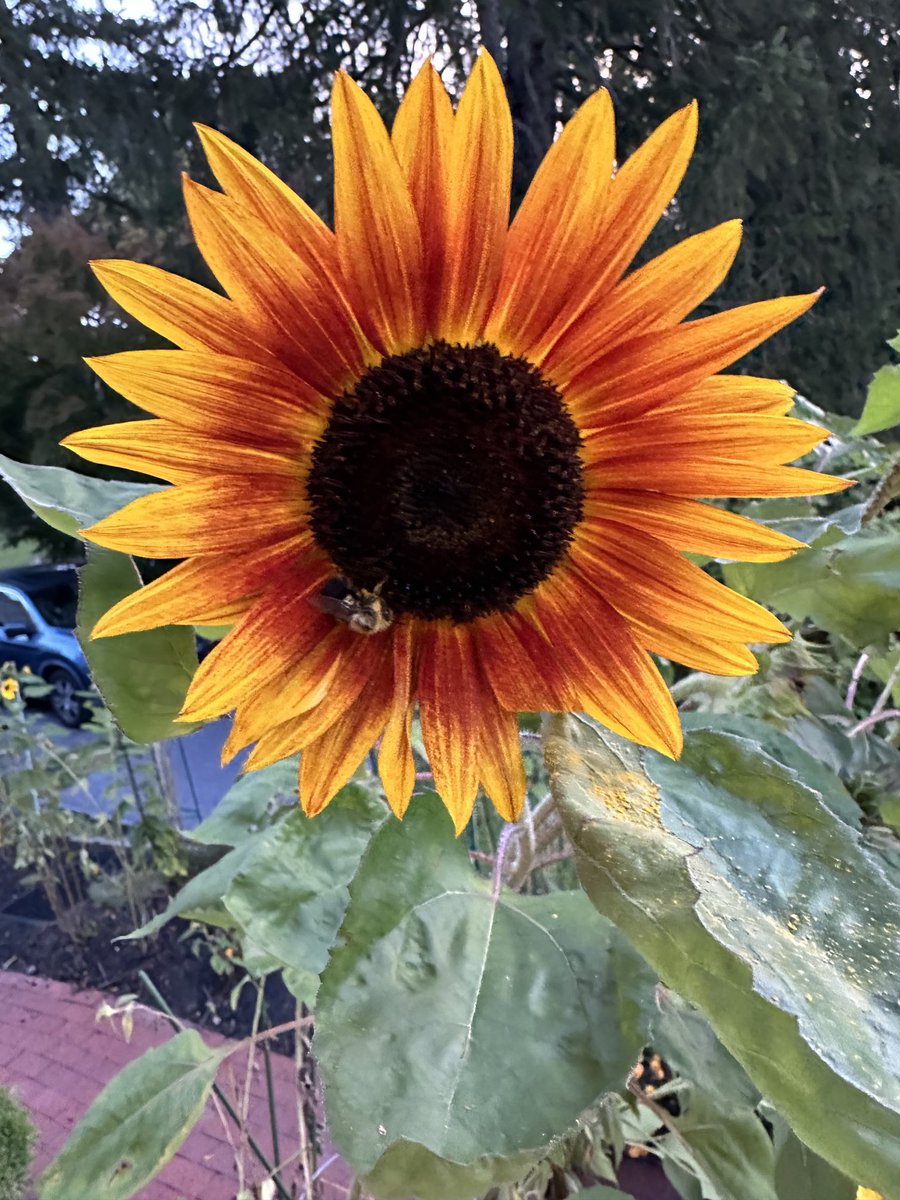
[77,545,198,742]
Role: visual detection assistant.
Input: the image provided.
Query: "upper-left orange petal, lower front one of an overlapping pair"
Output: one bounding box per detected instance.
[185,178,377,395]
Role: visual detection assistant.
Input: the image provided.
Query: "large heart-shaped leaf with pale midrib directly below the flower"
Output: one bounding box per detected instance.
[316,796,655,1200]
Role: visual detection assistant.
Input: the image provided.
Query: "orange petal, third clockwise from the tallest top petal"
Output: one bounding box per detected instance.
[541,221,742,388]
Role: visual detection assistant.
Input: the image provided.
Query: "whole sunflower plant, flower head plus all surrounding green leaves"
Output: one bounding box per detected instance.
[0,28,900,1200]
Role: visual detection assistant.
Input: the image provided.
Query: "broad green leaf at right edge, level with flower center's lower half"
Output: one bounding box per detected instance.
[724,532,900,649]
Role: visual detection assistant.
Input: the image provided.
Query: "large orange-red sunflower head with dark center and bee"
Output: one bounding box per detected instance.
[64,53,845,829]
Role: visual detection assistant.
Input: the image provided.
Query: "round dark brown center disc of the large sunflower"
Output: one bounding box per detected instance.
[307,342,583,622]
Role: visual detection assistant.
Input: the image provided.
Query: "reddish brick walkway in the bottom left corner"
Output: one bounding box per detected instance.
[0,971,349,1200]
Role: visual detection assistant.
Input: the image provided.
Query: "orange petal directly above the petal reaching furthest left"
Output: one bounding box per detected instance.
[85,350,328,450]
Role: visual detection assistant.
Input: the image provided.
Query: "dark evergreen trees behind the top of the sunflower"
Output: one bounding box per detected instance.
[0,0,900,549]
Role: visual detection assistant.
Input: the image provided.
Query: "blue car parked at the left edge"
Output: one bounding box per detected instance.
[0,566,91,728]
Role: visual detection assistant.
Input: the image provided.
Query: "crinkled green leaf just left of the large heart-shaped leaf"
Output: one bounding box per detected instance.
[224,784,388,977]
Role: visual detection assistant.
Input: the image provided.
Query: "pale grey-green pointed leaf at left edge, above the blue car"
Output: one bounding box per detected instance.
[0,455,162,536]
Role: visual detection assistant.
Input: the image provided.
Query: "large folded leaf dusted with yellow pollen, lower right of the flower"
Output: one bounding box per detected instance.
[546,716,900,1195]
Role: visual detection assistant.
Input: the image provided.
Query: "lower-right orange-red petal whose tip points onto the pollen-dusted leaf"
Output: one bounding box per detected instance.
[534,568,682,758]
